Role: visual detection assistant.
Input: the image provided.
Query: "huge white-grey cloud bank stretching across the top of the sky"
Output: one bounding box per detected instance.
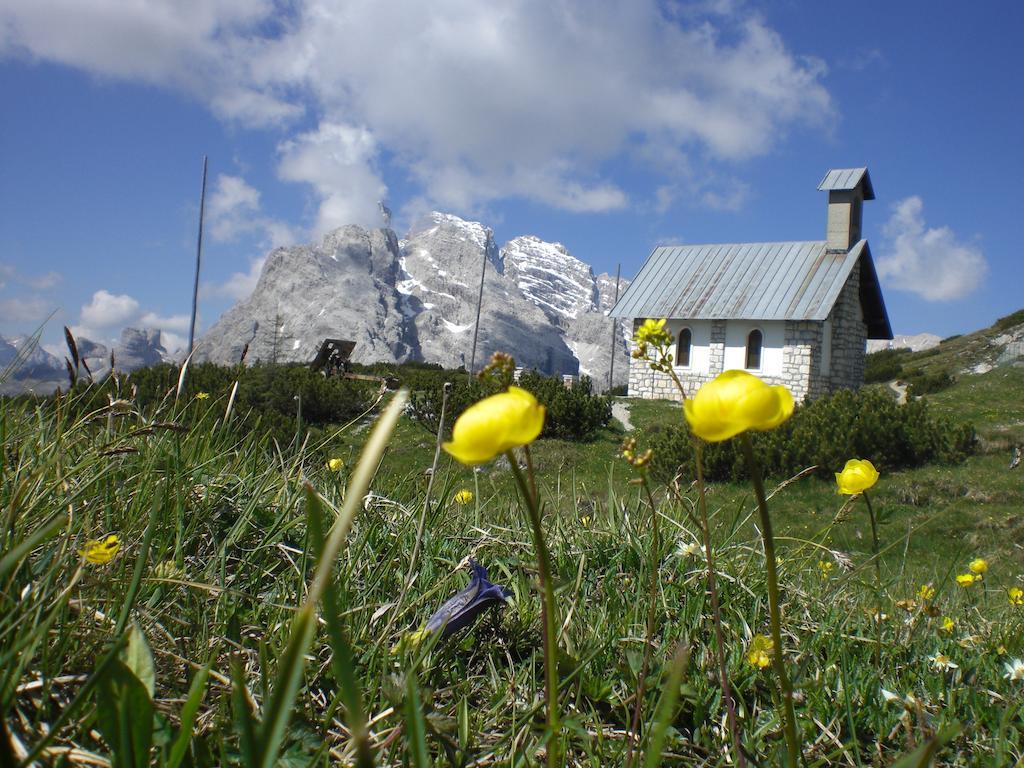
[0,0,833,217]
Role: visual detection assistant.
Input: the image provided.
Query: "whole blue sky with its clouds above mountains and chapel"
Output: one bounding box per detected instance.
[0,0,1024,348]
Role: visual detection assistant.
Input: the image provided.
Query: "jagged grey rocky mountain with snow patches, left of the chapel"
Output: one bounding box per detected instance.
[197,212,630,388]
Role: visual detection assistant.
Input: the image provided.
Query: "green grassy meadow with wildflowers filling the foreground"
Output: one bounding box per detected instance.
[0,358,1024,768]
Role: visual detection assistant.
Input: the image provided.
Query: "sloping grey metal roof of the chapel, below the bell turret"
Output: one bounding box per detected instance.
[611,240,892,339]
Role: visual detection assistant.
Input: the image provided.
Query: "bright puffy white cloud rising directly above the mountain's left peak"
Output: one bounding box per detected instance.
[278,122,387,234]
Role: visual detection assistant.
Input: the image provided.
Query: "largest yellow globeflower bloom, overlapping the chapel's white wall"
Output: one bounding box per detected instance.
[683,371,793,442]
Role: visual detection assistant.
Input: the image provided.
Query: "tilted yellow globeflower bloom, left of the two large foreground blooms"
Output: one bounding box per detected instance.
[443,387,544,464]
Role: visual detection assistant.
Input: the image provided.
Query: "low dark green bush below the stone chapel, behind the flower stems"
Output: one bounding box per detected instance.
[649,389,975,480]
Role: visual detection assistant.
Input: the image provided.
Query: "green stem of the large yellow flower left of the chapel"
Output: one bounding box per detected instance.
[505,447,561,768]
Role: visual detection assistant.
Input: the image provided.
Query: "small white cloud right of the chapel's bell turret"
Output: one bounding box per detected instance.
[878,196,988,301]
